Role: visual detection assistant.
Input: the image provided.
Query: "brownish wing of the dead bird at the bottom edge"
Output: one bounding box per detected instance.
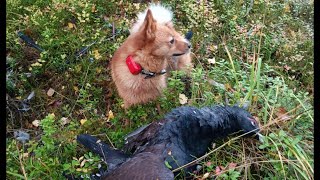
[101,152,174,180]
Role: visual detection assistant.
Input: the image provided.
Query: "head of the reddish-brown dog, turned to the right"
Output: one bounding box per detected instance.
[138,9,191,57]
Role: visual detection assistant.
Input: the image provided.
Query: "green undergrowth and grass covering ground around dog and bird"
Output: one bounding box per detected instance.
[6,0,314,179]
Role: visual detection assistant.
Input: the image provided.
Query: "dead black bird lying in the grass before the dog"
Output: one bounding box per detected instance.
[77,106,261,180]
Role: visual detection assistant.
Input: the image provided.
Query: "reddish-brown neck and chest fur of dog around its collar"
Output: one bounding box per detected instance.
[111,39,167,107]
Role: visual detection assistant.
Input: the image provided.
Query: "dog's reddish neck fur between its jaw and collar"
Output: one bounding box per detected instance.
[134,51,168,73]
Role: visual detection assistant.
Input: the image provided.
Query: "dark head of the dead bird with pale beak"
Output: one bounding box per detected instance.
[232,106,263,142]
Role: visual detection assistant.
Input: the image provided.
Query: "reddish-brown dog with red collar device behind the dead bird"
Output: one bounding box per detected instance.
[111,9,190,108]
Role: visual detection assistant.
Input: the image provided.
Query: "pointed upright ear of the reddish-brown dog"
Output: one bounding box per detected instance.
[141,9,157,41]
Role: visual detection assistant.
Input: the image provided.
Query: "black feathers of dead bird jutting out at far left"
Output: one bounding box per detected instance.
[77,134,129,171]
